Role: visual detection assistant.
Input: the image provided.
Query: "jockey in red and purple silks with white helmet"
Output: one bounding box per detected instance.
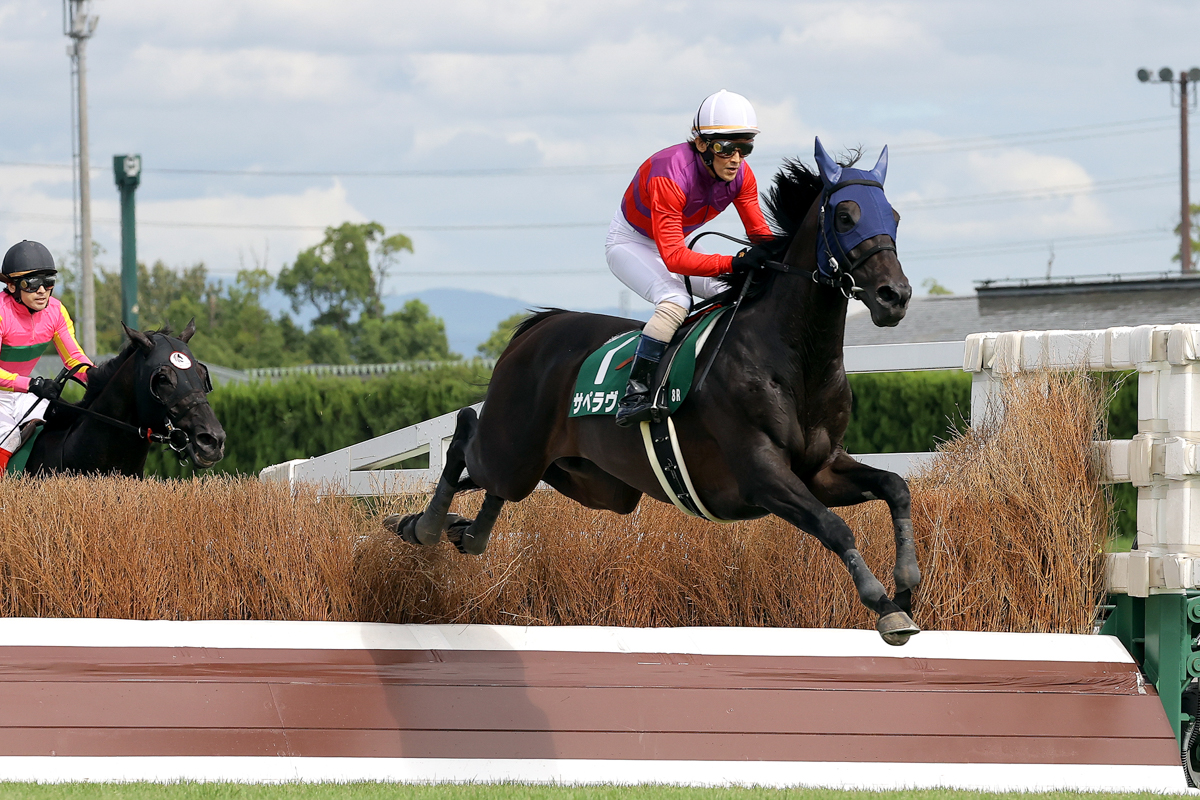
[605,89,772,426]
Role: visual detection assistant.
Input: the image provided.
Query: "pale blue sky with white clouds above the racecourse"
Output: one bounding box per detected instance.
[0,0,1200,308]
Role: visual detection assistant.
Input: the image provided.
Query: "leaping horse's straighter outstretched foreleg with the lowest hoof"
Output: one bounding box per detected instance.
[742,447,920,645]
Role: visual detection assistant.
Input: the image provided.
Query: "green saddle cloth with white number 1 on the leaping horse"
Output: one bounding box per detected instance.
[568,308,726,416]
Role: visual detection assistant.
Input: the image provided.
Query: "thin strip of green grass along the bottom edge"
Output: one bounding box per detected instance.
[0,782,1186,800]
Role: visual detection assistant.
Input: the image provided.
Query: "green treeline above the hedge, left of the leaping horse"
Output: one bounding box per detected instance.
[55,223,461,369]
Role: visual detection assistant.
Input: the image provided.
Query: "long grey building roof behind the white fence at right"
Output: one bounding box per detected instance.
[846,275,1200,345]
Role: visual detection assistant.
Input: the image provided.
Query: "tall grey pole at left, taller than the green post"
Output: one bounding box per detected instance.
[62,0,100,355]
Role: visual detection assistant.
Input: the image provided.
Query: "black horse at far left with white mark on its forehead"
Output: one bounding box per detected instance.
[25,320,226,477]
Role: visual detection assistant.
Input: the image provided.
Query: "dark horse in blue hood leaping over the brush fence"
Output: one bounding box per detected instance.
[385,142,920,644]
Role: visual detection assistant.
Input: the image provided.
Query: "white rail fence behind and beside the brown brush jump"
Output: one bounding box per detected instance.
[260,325,1200,597]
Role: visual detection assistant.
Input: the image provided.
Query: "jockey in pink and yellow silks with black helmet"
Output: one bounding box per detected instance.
[0,241,91,473]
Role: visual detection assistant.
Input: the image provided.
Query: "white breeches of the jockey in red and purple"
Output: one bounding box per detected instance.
[605,209,728,308]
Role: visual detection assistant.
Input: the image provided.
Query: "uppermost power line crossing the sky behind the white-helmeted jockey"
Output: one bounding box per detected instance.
[0,116,1175,178]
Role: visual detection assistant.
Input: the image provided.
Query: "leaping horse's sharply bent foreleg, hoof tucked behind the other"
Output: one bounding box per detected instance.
[812,452,920,614]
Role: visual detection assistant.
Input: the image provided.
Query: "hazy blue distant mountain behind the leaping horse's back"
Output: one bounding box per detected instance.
[383,289,653,357]
